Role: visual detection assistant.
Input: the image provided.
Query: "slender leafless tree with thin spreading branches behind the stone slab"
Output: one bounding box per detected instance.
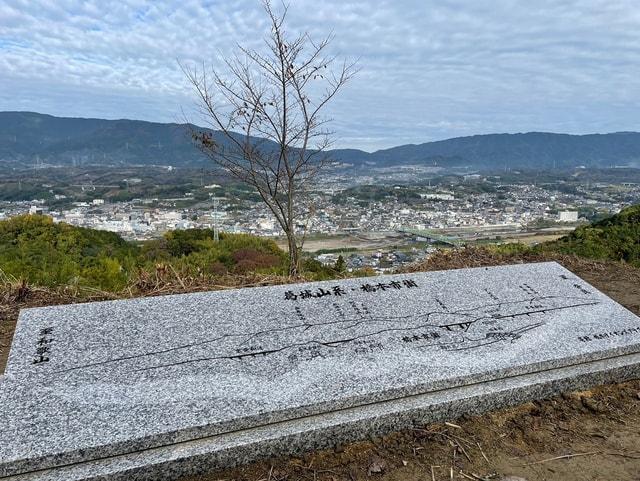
[183,0,356,276]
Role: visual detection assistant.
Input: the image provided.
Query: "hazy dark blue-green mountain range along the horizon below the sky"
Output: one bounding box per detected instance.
[0,112,640,171]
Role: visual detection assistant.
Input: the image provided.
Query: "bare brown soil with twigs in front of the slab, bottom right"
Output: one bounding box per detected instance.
[183,381,640,481]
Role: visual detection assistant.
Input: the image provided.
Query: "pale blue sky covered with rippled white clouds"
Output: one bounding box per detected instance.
[0,0,640,150]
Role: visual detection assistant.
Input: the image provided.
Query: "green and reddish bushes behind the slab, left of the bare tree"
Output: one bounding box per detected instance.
[0,215,287,292]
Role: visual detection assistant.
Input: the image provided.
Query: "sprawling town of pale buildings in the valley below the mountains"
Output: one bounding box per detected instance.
[0,164,640,272]
